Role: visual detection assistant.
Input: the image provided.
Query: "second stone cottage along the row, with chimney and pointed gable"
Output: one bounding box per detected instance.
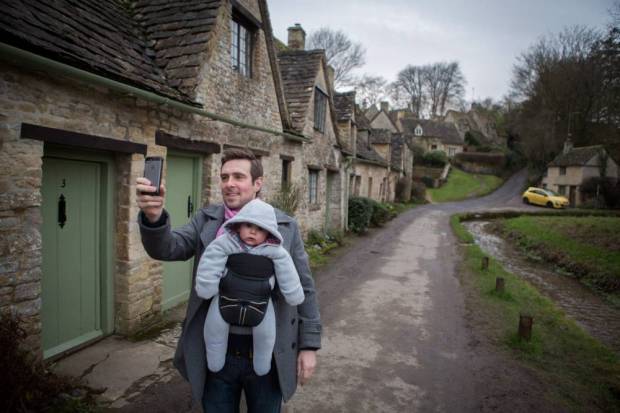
[278,24,348,233]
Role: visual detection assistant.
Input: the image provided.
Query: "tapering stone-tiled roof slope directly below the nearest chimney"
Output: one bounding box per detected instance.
[278,50,325,131]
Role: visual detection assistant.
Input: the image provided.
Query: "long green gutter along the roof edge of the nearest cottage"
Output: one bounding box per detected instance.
[0,42,310,142]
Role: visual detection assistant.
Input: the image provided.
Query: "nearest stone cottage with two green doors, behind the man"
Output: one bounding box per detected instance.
[0,0,334,359]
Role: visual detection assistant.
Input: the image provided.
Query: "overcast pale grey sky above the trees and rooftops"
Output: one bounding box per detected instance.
[268,0,614,100]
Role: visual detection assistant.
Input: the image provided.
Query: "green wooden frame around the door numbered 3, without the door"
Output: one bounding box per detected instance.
[39,143,117,358]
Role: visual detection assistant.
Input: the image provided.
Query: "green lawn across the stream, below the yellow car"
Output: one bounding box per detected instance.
[499,216,620,304]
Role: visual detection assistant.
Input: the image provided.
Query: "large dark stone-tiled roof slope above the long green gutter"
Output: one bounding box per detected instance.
[0,0,222,102]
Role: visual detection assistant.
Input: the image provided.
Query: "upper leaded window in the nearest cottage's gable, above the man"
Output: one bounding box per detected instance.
[230,6,260,79]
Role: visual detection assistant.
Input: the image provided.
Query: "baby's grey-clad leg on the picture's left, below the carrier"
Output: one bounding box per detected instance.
[204,295,230,373]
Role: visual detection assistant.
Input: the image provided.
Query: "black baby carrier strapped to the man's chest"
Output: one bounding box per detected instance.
[219,253,275,327]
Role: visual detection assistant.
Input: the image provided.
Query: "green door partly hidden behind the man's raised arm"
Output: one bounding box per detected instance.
[162,153,201,310]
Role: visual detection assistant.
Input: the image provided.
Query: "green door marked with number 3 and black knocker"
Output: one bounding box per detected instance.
[42,157,103,358]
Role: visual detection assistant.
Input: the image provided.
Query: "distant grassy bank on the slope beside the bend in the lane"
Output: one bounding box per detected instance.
[428,168,503,202]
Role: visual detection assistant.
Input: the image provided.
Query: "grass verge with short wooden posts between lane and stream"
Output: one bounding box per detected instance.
[453,214,620,411]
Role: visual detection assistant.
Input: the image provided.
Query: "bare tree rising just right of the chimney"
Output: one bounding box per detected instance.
[308,27,366,87]
